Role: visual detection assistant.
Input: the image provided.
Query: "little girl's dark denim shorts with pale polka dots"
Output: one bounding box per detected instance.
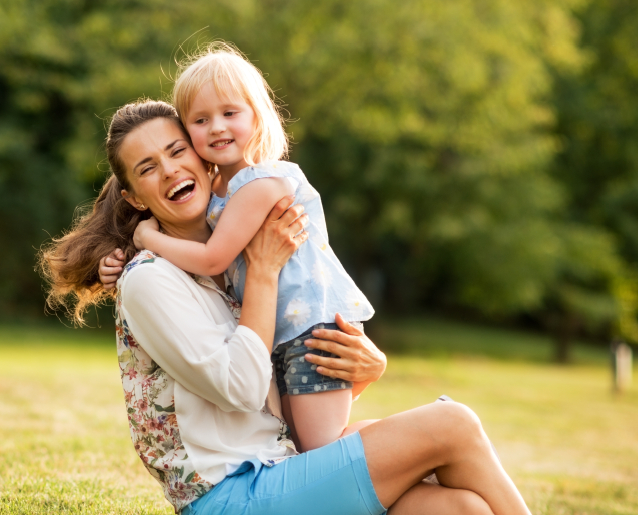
[271,322,363,396]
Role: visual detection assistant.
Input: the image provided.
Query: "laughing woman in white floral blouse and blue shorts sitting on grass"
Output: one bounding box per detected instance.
[38,101,529,515]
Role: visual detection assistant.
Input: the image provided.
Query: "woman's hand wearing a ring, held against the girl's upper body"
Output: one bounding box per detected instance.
[242,196,308,274]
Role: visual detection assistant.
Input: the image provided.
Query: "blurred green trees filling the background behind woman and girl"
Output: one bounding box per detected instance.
[0,0,638,354]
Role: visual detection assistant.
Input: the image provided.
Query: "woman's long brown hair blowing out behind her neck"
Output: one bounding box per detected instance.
[38,100,186,325]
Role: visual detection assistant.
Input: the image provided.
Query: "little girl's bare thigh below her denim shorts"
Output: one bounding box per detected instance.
[292,390,352,452]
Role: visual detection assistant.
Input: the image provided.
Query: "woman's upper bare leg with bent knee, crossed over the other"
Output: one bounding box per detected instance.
[360,402,530,515]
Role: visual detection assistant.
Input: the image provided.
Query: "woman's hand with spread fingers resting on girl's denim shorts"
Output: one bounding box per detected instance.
[304,314,387,388]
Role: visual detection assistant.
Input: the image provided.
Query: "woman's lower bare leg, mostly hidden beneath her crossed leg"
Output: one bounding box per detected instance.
[388,483,493,515]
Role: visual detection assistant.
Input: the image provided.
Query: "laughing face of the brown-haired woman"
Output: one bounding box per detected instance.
[120,118,210,232]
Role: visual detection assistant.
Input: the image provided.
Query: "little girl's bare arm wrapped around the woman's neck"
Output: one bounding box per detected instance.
[135,177,293,276]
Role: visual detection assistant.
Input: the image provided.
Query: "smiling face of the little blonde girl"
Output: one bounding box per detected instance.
[184,82,255,174]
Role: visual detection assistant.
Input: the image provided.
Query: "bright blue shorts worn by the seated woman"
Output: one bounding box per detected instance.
[182,433,386,515]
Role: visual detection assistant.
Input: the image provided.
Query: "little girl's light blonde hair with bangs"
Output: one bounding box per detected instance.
[173,41,288,165]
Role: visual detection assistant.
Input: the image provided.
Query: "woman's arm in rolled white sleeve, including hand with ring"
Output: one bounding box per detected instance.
[122,198,307,411]
